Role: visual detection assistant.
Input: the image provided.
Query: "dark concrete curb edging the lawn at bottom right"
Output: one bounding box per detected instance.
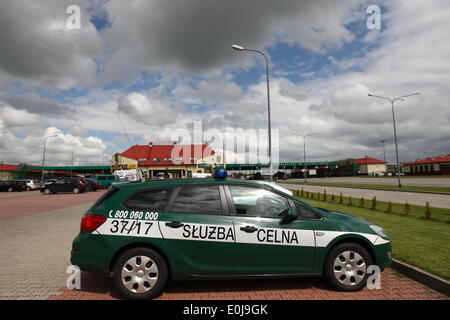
[391,259,450,297]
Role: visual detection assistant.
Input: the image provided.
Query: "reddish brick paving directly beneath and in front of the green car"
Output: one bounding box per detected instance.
[49,268,448,300]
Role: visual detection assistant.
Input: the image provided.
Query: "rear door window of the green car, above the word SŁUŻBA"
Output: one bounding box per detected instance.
[170,186,222,214]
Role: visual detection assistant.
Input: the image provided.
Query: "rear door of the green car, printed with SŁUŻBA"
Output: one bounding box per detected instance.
[159,185,235,276]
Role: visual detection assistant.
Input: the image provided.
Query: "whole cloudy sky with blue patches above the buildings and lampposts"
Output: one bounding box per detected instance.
[0,0,450,168]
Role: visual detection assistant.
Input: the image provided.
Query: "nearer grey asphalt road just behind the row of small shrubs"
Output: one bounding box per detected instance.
[278,183,450,209]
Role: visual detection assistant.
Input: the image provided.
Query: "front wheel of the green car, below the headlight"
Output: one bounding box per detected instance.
[324,242,372,291]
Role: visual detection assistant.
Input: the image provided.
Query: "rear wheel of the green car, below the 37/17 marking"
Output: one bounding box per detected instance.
[113,247,169,300]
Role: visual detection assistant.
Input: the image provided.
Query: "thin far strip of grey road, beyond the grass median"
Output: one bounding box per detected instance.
[289,177,450,187]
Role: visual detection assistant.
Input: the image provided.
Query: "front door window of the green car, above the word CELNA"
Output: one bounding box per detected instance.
[229,186,290,218]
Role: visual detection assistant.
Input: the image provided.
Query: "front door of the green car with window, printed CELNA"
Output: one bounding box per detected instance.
[225,185,315,275]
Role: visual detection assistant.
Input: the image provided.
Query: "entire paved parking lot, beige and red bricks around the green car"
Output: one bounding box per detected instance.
[0,191,448,300]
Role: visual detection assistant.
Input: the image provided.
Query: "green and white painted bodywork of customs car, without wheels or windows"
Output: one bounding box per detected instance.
[71,179,391,280]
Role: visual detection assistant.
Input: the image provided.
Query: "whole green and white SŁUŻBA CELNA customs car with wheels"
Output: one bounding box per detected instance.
[71,171,391,299]
